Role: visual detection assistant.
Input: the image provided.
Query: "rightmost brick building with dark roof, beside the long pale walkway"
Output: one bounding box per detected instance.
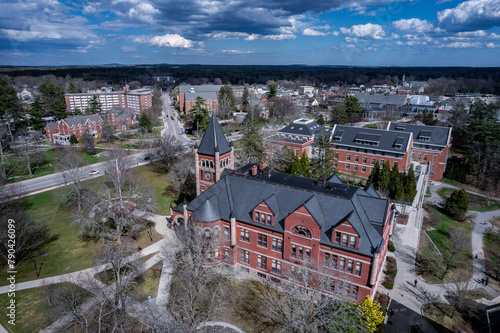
[387,123,452,180]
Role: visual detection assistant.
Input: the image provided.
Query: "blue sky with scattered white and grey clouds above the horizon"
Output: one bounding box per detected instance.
[0,0,500,67]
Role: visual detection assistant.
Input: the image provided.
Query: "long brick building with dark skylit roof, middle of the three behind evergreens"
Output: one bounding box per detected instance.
[330,125,413,178]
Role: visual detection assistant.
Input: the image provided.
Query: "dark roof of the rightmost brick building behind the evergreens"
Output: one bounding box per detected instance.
[388,122,451,147]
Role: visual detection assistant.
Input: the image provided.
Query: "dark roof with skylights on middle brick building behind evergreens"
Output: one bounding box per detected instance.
[331,125,411,154]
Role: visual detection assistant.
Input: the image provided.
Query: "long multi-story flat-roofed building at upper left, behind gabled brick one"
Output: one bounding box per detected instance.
[64,85,153,114]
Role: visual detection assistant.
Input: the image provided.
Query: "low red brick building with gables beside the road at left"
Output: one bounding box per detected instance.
[45,114,103,145]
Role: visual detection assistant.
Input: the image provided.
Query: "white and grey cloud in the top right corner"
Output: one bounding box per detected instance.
[437,0,500,31]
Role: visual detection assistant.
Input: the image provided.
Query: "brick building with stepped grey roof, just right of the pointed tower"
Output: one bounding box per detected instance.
[264,118,331,157]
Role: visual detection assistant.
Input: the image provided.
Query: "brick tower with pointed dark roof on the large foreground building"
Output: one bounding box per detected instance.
[195,115,234,196]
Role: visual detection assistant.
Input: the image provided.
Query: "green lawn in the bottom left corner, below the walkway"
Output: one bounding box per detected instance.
[0,282,90,333]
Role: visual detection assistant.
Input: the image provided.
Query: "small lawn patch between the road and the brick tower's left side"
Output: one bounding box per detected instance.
[135,163,179,215]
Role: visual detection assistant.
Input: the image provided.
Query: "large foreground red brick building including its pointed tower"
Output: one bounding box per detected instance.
[172,117,394,302]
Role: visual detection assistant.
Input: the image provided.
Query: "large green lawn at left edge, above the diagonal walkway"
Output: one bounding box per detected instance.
[0,191,97,285]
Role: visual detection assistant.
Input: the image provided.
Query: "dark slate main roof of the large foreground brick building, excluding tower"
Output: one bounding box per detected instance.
[174,164,390,256]
